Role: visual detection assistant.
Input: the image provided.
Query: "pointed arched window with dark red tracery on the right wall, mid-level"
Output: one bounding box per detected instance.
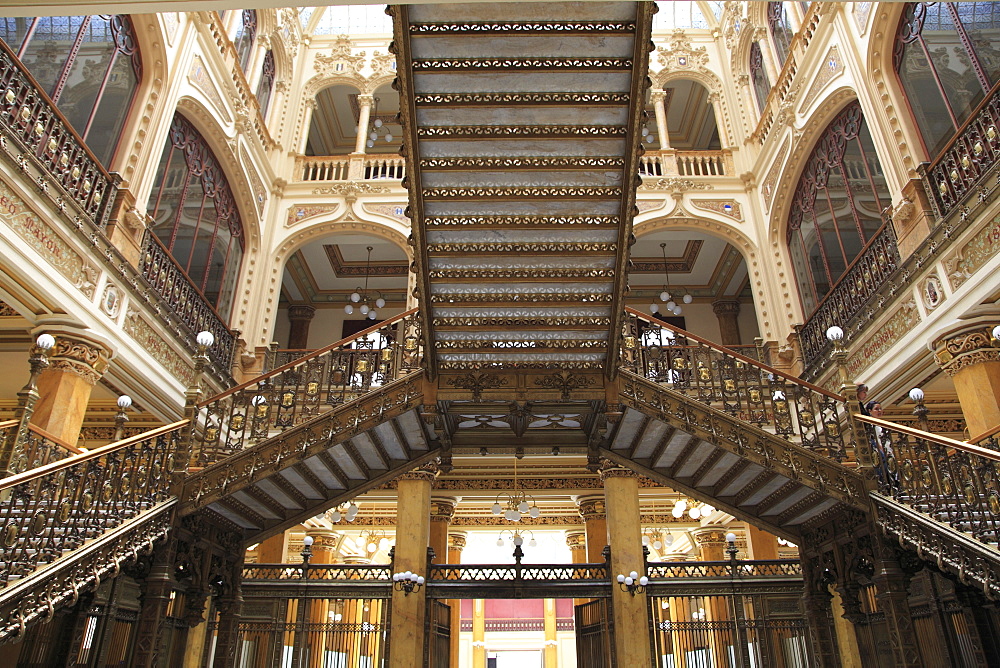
[786,102,891,316]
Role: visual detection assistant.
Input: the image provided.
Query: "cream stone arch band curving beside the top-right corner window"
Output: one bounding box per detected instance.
[862,2,928,180]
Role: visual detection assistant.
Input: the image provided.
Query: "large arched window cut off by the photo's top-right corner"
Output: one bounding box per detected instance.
[893,2,1000,158]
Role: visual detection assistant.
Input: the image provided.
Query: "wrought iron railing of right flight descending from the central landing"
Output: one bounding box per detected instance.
[621,307,853,461]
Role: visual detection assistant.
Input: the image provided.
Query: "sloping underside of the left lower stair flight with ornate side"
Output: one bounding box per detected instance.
[180,372,439,541]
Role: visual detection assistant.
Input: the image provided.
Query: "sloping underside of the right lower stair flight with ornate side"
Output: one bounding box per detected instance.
[602,371,868,540]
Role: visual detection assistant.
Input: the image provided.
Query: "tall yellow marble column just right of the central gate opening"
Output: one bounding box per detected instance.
[588,466,652,668]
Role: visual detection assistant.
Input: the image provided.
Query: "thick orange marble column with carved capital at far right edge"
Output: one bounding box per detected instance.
[934,317,1000,439]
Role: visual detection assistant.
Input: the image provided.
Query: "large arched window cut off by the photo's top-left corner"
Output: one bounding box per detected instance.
[0,16,142,167]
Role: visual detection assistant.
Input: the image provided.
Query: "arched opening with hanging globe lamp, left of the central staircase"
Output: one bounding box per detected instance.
[273,233,410,356]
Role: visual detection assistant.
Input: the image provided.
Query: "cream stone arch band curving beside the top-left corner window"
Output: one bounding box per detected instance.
[110,14,168,193]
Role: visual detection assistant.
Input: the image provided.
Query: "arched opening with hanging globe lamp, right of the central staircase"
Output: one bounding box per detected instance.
[629,229,759,352]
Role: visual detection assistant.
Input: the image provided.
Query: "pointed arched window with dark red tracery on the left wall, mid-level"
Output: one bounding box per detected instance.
[146,114,243,318]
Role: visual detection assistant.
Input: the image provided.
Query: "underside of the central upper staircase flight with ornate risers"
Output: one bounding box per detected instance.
[393,2,653,370]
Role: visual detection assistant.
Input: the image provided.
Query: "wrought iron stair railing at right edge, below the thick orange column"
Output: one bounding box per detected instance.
[856,415,1000,546]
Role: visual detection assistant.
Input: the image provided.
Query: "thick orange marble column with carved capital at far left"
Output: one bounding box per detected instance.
[31,330,112,446]
